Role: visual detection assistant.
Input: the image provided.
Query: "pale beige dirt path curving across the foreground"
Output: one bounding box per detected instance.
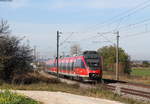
[15,91,123,104]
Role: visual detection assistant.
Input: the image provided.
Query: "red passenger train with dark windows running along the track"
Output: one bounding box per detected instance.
[46,51,102,81]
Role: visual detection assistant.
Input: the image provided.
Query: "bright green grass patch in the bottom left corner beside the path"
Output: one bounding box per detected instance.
[0,90,39,104]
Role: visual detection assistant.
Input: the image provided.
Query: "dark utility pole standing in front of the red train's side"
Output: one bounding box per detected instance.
[56,31,61,79]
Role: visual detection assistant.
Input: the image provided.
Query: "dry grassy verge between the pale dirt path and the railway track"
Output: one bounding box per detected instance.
[0,83,148,104]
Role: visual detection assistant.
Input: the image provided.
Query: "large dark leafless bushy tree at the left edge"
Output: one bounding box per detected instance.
[0,19,33,81]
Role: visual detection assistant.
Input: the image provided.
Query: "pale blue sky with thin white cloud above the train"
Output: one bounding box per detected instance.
[0,0,150,60]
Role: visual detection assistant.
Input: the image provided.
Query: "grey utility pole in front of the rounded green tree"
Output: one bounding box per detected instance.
[115,31,120,80]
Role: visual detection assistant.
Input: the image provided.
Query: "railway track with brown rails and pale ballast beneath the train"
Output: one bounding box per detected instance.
[39,73,150,102]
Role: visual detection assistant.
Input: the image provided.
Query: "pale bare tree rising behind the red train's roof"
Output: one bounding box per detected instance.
[70,44,81,55]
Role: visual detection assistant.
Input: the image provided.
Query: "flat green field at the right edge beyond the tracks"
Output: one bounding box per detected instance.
[131,68,150,77]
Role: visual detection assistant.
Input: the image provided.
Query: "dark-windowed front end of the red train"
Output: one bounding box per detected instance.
[83,51,102,80]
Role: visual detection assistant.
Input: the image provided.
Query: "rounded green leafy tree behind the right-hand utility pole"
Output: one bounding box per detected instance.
[98,46,131,74]
